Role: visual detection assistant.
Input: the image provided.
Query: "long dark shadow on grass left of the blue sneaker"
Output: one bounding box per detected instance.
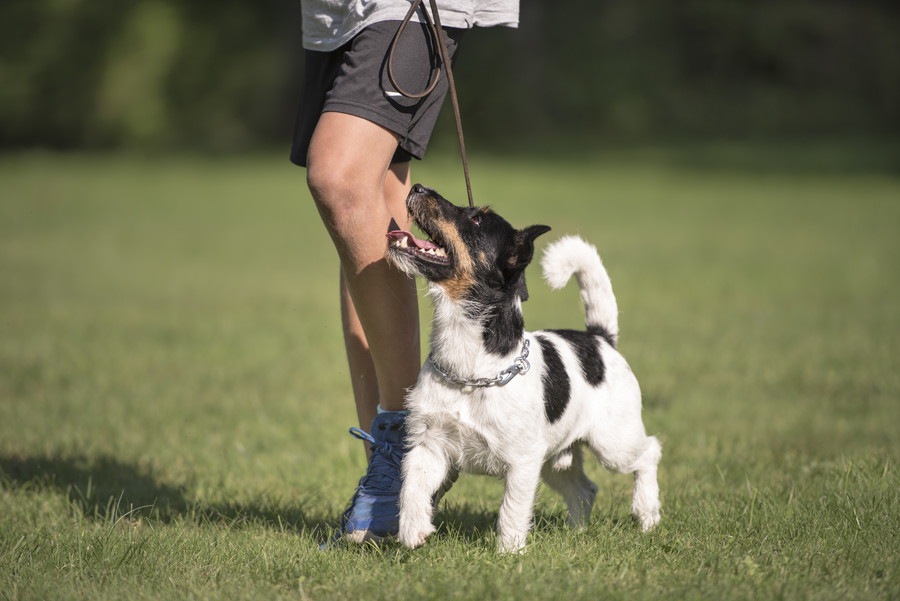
[0,455,335,534]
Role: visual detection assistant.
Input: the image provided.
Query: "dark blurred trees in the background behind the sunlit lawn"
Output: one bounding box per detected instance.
[0,0,900,151]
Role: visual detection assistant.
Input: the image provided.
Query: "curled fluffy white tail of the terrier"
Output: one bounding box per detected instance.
[541,236,619,347]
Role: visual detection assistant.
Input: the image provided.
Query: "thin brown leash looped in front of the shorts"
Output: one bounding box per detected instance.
[387,0,475,207]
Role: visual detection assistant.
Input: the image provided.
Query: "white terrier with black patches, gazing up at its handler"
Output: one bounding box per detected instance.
[386,184,662,553]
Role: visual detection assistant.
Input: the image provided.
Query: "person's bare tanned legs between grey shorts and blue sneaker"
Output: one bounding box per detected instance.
[307,112,420,440]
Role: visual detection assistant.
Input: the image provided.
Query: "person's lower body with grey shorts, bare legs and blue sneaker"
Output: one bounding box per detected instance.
[291,23,459,542]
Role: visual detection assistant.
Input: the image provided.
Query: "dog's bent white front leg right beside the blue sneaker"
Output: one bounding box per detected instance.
[398,444,449,549]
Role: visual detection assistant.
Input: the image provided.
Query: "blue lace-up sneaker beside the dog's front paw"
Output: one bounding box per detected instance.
[341,412,406,543]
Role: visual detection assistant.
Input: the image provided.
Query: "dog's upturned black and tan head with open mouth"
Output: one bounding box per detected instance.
[387,184,550,300]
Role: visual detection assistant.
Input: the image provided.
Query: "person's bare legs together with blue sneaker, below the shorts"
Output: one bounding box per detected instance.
[307,112,419,542]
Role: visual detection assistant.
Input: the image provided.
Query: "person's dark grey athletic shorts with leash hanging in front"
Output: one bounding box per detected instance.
[291,21,465,167]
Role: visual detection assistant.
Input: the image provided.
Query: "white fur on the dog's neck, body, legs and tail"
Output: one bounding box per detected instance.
[398,237,661,553]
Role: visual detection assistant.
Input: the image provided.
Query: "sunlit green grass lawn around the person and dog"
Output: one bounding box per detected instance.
[0,146,900,600]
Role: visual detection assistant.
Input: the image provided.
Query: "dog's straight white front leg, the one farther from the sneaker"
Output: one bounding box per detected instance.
[497,459,541,553]
